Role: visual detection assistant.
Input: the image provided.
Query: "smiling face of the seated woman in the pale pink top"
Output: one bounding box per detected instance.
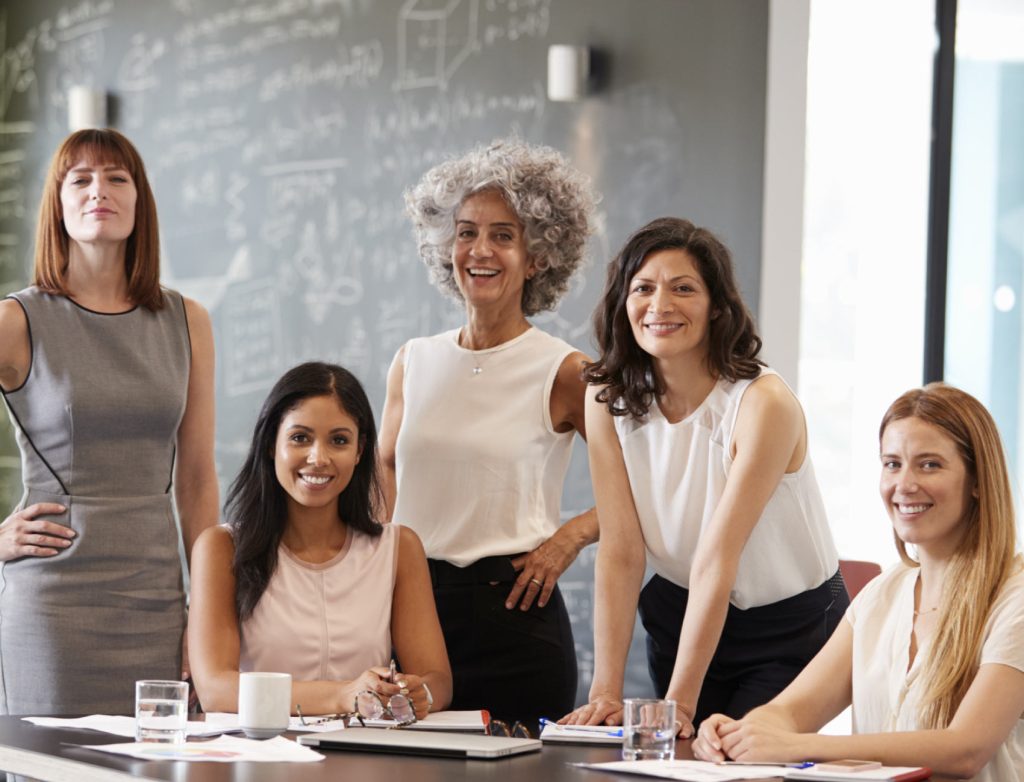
[273,395,361,510]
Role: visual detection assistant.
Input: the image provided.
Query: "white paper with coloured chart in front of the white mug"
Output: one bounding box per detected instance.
[81,736,324,763]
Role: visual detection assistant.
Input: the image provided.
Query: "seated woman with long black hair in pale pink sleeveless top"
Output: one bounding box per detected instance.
[188,362,452,719]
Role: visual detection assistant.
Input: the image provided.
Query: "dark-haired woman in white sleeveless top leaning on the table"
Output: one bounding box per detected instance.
[563,218,848,736]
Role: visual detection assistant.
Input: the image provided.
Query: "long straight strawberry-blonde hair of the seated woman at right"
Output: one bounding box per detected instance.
[879,383,1017,729]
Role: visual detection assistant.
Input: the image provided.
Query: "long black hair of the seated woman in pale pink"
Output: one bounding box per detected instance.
[224,361,382,619]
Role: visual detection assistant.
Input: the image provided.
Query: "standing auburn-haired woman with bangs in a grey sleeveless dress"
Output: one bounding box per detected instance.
[0,129,217,714]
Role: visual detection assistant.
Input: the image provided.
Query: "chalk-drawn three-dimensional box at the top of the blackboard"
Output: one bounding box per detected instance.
[394,0,480,90]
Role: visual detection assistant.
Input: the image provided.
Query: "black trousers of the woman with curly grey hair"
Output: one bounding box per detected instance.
[429,557,577,724]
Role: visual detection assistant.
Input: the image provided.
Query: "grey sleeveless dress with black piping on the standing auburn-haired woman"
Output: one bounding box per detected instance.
[0,288,190,714]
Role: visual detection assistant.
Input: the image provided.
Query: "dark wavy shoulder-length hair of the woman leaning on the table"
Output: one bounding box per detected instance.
[584,217,764,419]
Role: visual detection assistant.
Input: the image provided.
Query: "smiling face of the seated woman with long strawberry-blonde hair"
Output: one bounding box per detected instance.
[880,417,976,559]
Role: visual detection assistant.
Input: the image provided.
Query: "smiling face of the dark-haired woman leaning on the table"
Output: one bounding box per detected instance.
[626,250,712,358]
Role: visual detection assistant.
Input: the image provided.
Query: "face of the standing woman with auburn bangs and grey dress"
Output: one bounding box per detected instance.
[60,159,138,244]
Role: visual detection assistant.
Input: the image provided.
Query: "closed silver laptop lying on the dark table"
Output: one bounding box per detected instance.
[298,728,542,761]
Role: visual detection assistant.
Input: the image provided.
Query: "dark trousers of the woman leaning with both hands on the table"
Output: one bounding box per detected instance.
[640,572,850,727]
